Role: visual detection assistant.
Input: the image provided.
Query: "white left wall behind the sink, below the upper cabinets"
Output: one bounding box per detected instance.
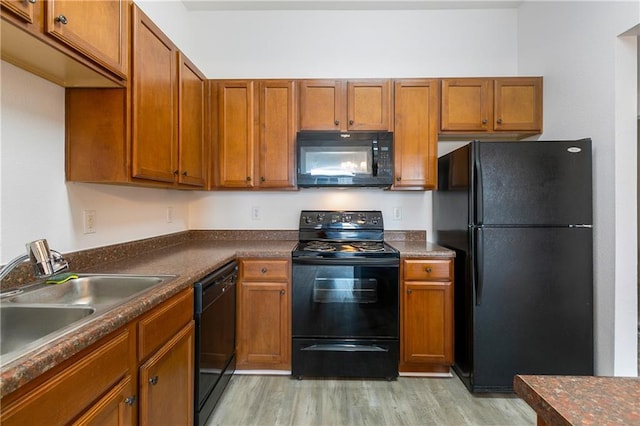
[0,62,193,264]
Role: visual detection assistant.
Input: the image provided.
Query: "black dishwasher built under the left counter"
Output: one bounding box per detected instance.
[194,261,238,425]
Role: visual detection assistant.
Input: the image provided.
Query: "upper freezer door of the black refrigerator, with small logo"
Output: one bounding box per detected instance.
[470,139,593,225]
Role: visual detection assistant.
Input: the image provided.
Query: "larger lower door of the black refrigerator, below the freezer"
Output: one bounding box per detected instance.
[471,228,593,392]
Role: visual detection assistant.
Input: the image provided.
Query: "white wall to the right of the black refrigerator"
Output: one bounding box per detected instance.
[518,1,638,376]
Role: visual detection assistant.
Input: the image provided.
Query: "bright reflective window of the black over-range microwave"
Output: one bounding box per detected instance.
[300,146,372,176]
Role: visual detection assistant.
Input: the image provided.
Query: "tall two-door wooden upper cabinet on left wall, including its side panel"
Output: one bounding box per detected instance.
[66,5,207,189]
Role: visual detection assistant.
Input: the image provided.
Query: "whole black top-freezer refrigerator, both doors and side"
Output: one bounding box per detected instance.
[433,139,593,392]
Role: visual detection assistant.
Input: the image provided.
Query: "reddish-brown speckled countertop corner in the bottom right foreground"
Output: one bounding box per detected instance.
[513,375,640,426]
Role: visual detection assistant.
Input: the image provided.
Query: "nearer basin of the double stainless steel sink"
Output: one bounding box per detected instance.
[0,305,95,362]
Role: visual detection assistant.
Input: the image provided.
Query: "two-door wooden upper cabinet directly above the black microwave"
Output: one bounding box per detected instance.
[299,79,393,131]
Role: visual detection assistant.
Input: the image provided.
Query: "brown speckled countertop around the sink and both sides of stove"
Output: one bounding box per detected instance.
[0,231,454,398]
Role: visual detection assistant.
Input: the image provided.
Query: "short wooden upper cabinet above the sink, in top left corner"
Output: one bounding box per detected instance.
[0,0,129,87]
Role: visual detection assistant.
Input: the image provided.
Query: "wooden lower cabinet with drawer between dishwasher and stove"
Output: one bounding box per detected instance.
[237,258,291,370]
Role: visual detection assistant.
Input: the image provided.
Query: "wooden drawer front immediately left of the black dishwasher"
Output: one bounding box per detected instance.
[138,288,193,360]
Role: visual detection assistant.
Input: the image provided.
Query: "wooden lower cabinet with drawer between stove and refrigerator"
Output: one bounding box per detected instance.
[400,258,453,374]
